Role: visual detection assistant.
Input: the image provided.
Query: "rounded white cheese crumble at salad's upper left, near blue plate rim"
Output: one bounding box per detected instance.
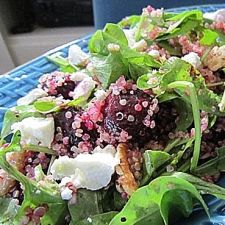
[68,45,89,65]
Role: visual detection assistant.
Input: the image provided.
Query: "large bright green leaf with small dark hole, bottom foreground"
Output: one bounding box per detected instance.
[110,176,208,225]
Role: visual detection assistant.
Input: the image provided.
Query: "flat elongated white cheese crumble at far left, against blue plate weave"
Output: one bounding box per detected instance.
[17,88,48,105]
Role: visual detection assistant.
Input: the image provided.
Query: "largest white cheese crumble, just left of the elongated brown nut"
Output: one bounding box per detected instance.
[50,145,119,190]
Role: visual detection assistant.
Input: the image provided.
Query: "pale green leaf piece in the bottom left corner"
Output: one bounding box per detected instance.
[0,198,19,225]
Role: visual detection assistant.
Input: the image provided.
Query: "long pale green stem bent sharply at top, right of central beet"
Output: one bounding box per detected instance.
[168,81,201,172]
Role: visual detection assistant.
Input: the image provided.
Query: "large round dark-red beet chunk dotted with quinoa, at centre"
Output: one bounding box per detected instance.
[103,85,158,139]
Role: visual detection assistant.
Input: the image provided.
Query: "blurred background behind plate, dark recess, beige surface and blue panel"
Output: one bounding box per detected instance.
[0,0,225,74]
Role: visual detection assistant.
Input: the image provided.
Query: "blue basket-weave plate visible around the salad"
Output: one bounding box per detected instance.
[0,4,225,225]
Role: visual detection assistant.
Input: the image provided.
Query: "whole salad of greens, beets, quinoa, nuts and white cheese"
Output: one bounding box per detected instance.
[0,6,225,225]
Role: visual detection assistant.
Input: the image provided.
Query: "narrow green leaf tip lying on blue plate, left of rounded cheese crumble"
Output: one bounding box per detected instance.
[46,52,78,73]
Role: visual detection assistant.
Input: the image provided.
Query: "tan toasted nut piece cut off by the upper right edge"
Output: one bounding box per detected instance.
[204,45,225,71]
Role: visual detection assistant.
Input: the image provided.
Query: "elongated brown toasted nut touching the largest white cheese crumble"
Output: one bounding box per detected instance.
[116,144,138,196]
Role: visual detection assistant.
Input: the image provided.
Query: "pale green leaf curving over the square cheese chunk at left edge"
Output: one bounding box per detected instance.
[1,105,43,139]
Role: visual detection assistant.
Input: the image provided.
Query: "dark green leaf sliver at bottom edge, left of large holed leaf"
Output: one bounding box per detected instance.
[75,211,118,225]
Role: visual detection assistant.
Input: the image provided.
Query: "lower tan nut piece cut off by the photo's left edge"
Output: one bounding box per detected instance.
[0,169,16,197]
